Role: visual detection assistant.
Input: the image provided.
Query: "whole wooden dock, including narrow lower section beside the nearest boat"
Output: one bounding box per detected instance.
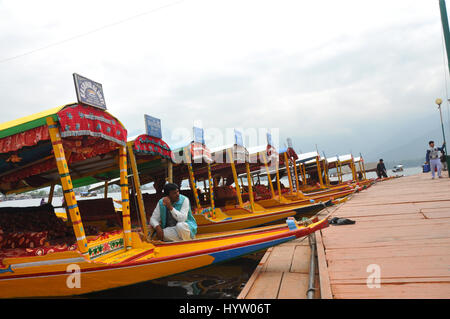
[238,172,450,299]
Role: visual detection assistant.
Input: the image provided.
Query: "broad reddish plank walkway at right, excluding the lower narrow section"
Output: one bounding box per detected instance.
[321,172,450,299]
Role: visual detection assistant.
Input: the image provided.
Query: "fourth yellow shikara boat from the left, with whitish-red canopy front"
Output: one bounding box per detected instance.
[186,144,330,229]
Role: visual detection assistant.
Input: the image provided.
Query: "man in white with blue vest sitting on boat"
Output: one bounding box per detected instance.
[150,183,197,241]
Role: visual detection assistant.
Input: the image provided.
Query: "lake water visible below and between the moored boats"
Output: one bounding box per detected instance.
[0,167,422,299]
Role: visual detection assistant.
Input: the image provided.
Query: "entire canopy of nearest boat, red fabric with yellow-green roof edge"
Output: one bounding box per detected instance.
[0,103,127,194]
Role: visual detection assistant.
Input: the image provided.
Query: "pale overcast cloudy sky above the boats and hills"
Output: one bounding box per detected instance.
[0,0,449,160]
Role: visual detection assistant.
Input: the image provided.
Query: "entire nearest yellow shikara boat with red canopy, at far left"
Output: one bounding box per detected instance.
[0,104,328,298]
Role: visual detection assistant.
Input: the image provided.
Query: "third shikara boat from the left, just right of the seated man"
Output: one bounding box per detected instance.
[139,142,318,234]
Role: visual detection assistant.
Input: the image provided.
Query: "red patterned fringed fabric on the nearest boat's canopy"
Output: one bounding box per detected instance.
[0,104,127,189]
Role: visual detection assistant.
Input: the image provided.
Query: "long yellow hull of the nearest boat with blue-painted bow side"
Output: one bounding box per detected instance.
[0,219,328,298]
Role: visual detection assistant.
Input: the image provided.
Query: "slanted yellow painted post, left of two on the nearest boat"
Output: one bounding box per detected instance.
[46,117,90,259]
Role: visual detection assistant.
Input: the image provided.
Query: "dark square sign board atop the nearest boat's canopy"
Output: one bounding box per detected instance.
[73,73,106,110]
